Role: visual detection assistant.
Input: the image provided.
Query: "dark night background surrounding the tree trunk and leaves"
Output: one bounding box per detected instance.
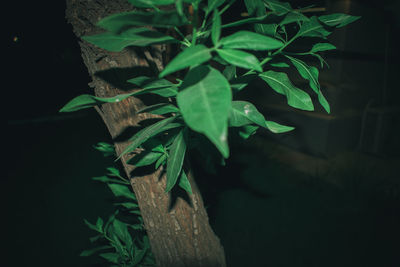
[0,1,400,267]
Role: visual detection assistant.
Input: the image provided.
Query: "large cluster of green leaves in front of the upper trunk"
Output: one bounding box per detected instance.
[61,0,359,193]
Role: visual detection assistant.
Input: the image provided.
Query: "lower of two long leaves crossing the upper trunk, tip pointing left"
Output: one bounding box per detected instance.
[82,28,179,52]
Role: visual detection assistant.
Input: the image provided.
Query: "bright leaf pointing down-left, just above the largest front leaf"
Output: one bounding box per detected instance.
[159,44,211,78]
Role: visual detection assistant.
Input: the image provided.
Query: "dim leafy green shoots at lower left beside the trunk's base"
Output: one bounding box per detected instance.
[81,142,154,267]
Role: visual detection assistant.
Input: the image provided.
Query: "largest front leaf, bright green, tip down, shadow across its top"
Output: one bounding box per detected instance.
[177,65,232,158]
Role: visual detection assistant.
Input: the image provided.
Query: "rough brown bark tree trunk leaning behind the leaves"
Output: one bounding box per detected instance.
[66,0,226,267]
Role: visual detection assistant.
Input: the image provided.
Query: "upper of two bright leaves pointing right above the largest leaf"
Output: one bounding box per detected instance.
[220,31,283,50]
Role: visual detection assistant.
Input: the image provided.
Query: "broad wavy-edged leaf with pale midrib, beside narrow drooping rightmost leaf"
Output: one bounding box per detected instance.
[259,70,314,111]
